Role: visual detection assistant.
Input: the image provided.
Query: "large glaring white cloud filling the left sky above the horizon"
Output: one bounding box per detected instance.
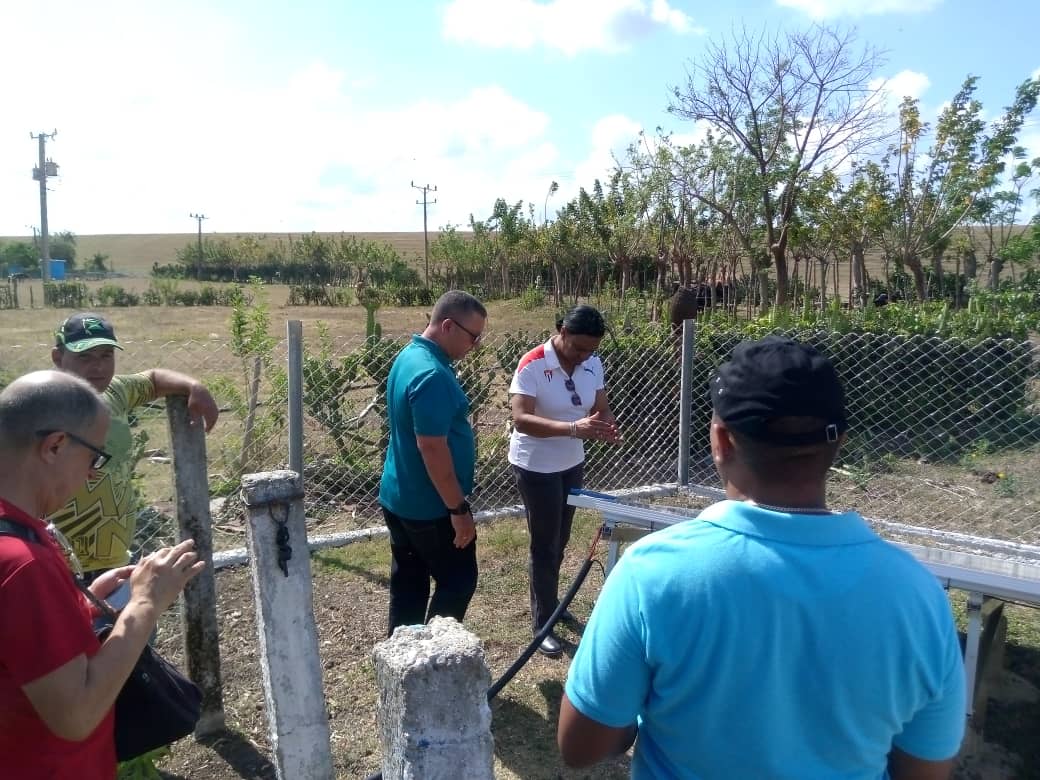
[0,0,678,235]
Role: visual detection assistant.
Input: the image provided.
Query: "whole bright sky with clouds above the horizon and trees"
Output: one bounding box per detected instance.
[0,0,1040,235]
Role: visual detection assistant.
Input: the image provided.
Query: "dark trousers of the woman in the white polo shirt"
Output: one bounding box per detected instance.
[513,463,584,633]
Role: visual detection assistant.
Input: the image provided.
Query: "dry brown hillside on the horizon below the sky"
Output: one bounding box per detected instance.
[0,231,455,276]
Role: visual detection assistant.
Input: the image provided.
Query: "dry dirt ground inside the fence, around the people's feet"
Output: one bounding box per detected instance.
[151,515,1040,780]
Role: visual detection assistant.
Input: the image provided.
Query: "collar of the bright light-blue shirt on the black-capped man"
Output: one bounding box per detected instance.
[698,500,881,547]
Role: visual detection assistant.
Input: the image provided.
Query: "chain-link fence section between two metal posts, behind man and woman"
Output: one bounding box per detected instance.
[293,333,679,527]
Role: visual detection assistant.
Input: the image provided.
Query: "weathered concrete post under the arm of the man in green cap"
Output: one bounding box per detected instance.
[166,395,224,737]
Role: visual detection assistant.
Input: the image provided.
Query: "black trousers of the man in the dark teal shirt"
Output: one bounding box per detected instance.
[383,506,476,636]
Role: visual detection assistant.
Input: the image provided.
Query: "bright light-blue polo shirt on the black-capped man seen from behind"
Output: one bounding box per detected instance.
[566,501,965,780]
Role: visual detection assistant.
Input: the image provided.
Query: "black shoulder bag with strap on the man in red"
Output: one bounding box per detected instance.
[0,518,202,761]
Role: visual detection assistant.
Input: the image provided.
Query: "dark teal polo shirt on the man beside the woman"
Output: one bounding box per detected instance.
[380,336,476,521]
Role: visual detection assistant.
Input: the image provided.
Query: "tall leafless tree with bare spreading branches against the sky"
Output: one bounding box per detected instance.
[669,26,885,306]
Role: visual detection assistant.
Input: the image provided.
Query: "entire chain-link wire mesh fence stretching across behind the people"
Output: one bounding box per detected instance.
[4,328,1040,550]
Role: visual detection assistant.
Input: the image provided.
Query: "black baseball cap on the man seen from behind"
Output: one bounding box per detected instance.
[708,336,849,446]
